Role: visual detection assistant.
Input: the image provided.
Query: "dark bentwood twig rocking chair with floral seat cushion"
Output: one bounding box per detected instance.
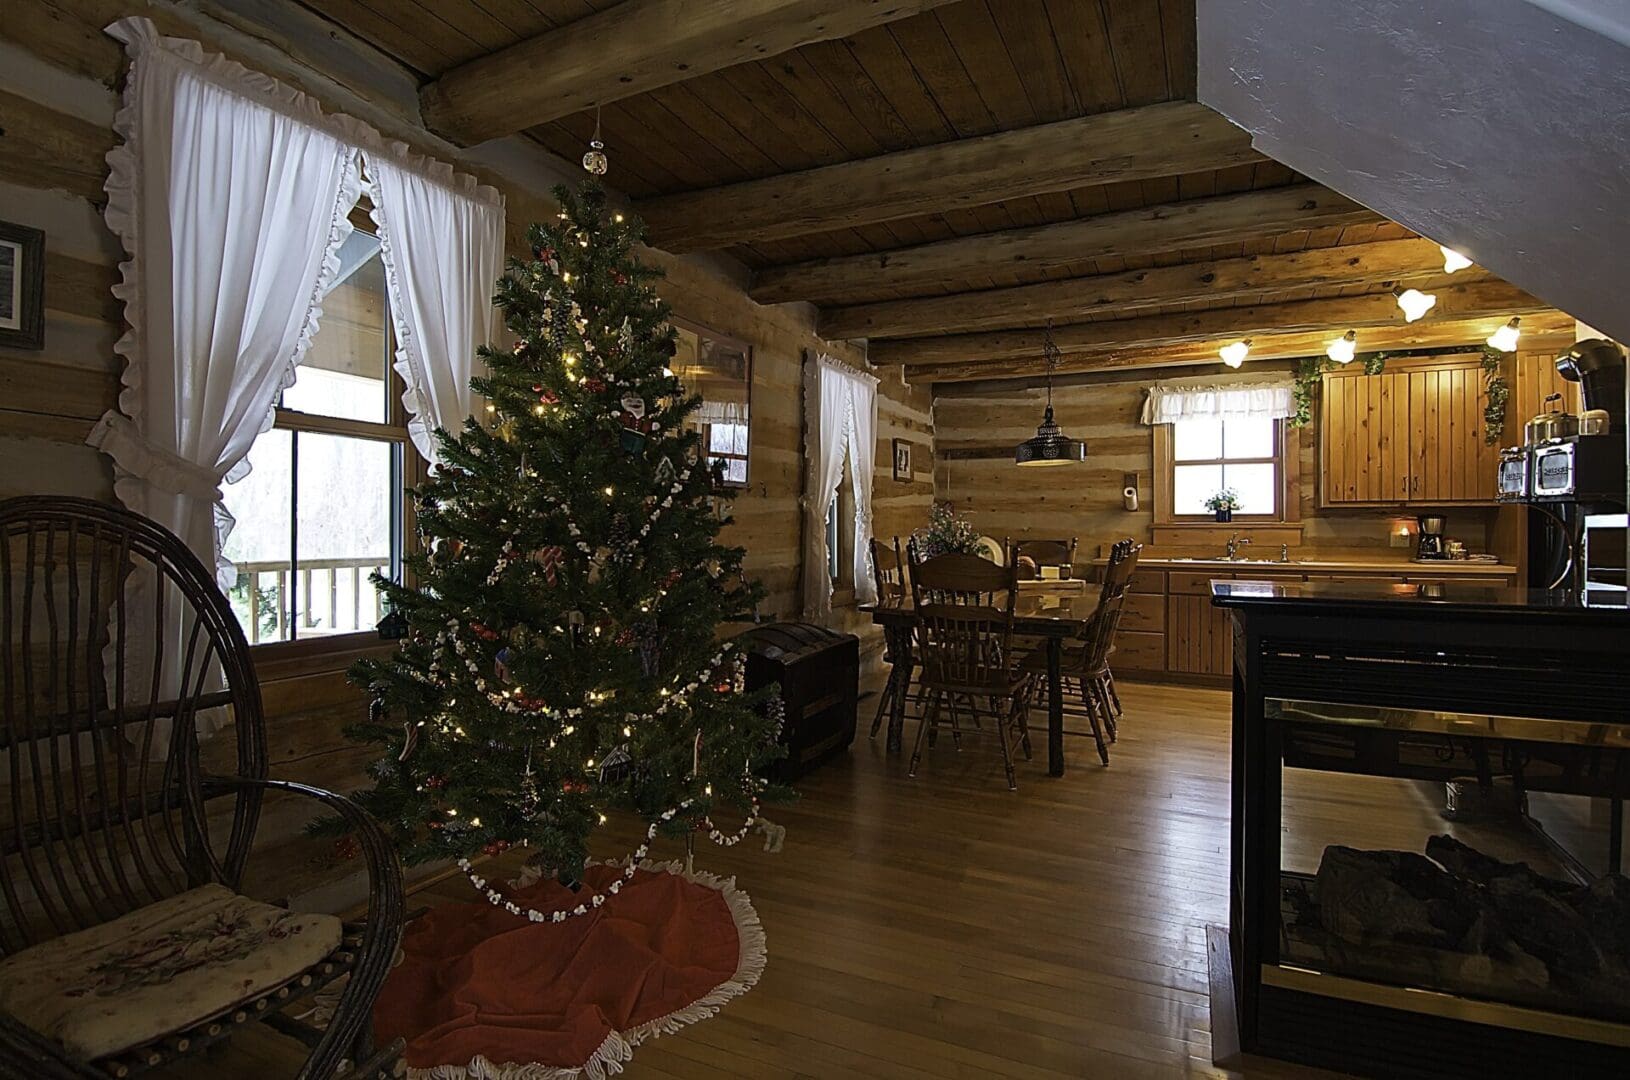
[0,497,403,1080]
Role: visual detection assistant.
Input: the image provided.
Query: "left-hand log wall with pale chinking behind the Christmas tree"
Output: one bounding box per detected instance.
[0,0,932,906]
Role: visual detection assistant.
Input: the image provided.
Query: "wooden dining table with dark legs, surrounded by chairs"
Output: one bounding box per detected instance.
[859,578,1099,777]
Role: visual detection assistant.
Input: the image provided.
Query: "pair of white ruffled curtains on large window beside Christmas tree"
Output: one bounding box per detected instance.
[88,18,504,588]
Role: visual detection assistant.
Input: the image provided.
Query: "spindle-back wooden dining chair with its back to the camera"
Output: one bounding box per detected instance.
[908,554,1030,792]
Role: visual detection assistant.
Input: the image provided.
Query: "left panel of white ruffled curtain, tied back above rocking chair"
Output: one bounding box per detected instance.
[88,18,360,588]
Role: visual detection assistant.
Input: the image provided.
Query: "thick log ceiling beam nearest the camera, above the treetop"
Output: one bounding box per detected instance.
[419,0,950,145]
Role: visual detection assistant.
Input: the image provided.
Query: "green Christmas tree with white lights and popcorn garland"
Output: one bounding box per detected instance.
[334,181,779,917]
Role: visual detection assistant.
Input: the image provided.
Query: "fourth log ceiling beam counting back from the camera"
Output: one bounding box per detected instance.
[820,239,1467,340]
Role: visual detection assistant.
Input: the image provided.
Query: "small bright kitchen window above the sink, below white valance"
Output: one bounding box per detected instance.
[1156,417,1289,521]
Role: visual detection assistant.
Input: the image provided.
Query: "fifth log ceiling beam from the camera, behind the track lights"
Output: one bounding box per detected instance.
[899,282,1552,377]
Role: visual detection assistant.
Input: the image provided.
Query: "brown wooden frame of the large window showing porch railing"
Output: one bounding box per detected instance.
[237,195,429,658]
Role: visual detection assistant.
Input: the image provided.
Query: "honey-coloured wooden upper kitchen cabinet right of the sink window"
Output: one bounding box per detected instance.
[1319,355,1500,507]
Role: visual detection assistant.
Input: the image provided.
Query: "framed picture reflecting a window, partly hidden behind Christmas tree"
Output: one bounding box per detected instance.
[668,319,753,487]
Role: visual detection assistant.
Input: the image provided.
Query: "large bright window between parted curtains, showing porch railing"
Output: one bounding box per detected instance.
[225,212,414,645]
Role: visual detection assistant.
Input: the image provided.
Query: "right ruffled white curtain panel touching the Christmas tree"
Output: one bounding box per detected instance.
[365,153,504,461]
